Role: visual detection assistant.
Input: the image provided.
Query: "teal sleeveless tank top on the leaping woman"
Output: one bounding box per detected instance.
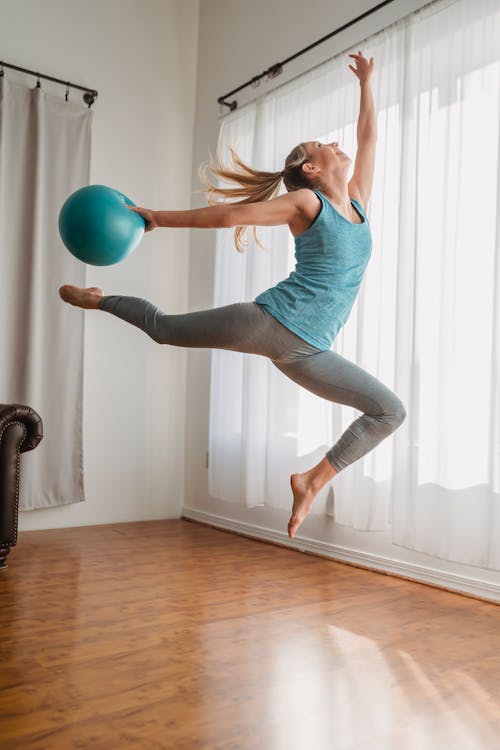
[254,190,372,351]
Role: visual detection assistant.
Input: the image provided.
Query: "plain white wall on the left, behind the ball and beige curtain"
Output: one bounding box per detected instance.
[0,0,198,530]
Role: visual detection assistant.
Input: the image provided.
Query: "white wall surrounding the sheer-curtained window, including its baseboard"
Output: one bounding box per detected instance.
[183,0,499,598]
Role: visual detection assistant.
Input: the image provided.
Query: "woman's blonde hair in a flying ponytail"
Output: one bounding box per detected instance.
[199,143,311,253]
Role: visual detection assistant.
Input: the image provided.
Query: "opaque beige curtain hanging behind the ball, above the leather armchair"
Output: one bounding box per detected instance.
[0,76,93,510]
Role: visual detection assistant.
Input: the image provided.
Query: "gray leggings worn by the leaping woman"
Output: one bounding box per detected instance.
[99,296,406,472]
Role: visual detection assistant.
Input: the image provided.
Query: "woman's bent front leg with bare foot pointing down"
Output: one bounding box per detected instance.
[273,350,406,537]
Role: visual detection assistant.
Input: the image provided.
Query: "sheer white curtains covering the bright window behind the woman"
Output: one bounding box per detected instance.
[209,0,500,569]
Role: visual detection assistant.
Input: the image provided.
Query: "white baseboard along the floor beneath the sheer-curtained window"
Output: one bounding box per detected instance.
[182,507,500,604]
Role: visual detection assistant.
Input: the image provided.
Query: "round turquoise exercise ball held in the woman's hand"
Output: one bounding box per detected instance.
[59,185,146,266]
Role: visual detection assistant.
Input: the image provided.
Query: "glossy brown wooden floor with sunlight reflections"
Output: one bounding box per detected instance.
[0,520,500,750]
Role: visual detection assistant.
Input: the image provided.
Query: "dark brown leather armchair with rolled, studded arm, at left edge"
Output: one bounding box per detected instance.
[0,404,43,569]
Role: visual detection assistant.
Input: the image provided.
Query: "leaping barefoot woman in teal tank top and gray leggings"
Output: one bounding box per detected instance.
[59,51,406,538]
